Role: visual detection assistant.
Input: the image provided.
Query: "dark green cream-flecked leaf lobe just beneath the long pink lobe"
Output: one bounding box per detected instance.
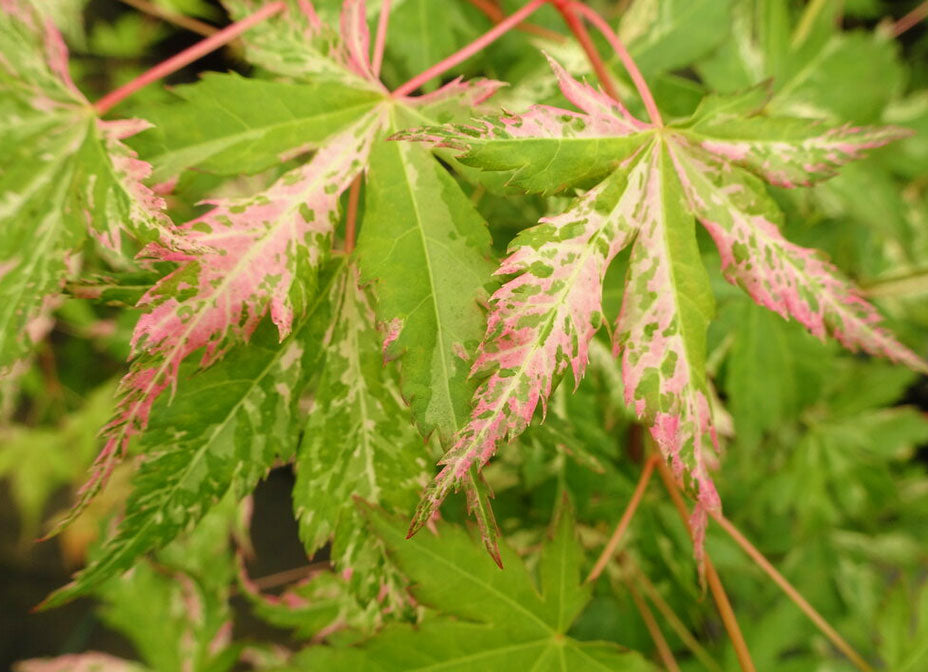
[42,263,344,604]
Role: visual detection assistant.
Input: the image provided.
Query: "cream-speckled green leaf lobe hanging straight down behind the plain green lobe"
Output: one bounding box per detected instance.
[293,266,427,608]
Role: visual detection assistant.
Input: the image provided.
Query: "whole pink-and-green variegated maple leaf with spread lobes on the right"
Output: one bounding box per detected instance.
[395,56,928,553]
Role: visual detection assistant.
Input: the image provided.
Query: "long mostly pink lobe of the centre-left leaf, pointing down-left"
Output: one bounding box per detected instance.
[48,109,384,531]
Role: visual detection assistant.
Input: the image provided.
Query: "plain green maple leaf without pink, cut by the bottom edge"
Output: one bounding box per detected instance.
[293,510,654,672]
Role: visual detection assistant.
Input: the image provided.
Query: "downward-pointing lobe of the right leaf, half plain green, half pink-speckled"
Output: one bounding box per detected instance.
[614,142,720,556]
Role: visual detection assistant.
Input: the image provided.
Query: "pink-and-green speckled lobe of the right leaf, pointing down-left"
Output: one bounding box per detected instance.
[410,169,635,540]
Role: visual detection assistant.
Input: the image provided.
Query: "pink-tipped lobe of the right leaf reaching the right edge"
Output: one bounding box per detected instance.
[675,143,928,372]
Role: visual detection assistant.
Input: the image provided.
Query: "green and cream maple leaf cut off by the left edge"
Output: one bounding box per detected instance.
[0,0,169,372]
